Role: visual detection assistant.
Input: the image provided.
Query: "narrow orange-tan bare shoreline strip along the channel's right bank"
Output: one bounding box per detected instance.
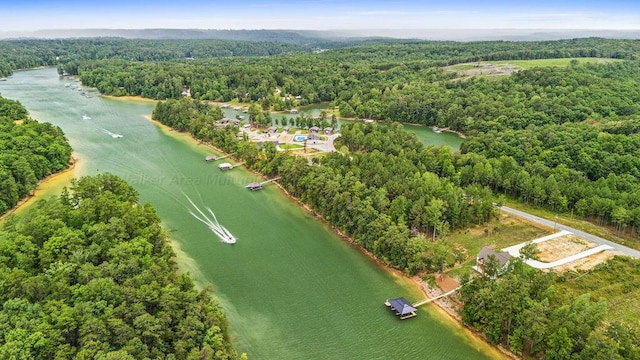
[144,114,510,359]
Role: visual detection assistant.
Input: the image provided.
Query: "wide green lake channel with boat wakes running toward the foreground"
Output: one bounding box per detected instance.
[0,69,499,359]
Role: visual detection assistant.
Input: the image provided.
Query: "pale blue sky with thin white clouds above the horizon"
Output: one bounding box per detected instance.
[0,0,640,32]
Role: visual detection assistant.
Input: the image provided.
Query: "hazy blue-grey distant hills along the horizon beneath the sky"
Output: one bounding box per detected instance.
[0,29,640,41]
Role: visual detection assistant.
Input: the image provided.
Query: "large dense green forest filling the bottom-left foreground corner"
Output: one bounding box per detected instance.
[0,174,236,359]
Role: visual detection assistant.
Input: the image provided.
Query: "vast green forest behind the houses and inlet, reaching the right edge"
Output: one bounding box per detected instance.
[79,39,640,236]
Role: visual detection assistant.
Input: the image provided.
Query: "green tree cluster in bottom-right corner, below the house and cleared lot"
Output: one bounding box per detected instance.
[459,258,640,360]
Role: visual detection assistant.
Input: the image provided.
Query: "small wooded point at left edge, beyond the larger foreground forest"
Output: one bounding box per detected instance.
[0,97,72,215]
